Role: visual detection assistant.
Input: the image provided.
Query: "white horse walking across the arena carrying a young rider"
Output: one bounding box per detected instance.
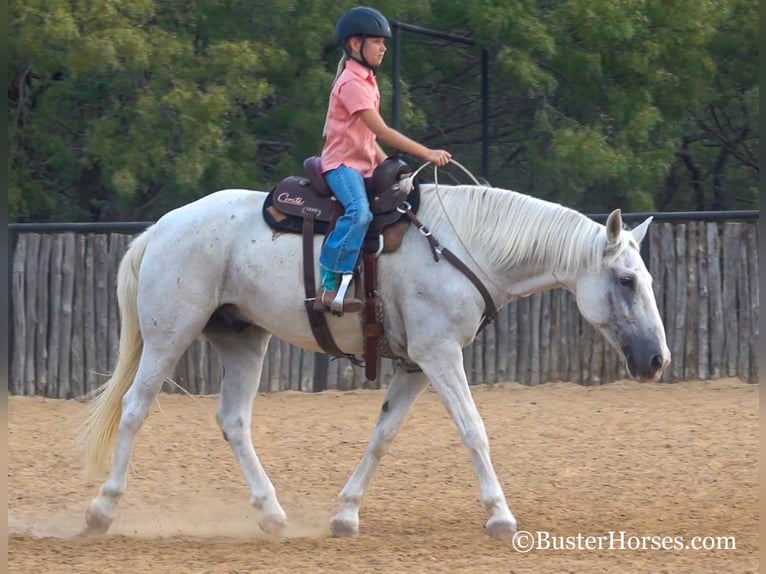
[82,184,670,539]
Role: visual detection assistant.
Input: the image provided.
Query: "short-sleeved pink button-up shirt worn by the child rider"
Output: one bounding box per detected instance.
[322,60,380,177]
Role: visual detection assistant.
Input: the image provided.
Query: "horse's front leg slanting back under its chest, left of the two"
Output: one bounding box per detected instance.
[330,369,428,537]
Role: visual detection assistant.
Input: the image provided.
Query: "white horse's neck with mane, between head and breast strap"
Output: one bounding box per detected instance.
[416,186,599,301]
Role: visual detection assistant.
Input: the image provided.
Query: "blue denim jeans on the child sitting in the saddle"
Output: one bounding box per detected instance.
[319,165,372,273]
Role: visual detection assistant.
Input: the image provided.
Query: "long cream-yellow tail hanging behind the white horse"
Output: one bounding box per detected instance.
[80,229,151,473]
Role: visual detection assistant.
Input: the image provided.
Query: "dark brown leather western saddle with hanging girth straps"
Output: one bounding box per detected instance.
[263,157,420,380]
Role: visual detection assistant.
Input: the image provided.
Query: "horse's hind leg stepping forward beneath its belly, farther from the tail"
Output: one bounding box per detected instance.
[205,326,287,534]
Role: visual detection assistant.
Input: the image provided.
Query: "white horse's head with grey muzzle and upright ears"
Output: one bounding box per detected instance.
[576,210,670,381]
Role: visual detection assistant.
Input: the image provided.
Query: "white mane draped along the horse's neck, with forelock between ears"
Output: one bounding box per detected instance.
[418,184,630,272]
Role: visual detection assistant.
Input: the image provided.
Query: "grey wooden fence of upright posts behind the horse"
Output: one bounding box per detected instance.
[9,222,759,398]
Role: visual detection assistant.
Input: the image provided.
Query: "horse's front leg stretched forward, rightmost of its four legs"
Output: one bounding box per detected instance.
[413,343,516,540]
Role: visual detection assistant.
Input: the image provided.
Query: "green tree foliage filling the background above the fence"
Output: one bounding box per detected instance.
[8,0,759,221]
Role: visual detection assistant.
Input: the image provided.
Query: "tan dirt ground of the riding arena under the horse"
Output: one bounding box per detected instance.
[8,379,759,574]
